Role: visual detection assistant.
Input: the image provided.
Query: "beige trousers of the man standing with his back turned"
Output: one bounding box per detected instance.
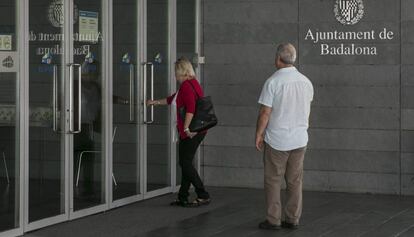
[264,144,306,225]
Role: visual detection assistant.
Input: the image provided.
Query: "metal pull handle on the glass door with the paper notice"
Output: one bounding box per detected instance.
[68,63,82,133]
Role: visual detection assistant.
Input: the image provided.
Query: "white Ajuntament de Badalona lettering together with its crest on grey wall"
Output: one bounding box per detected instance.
[303,0,398,56]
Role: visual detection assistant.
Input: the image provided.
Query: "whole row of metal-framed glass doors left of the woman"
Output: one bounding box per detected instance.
[0,0,201,236]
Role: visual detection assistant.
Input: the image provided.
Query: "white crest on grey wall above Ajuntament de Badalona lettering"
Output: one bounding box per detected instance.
[334,0,364,25]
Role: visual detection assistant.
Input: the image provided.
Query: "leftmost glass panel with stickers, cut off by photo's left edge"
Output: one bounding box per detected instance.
[0,0,21,235]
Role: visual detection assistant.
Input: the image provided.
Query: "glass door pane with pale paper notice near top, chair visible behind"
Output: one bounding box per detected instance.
[73,0,105,211]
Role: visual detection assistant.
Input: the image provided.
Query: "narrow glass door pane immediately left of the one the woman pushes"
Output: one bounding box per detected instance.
[113,0,140,200]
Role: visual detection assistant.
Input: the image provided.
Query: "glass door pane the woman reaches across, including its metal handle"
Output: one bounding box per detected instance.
[143,0,172,193]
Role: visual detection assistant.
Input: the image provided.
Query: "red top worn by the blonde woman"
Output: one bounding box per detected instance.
[167,78,206,139]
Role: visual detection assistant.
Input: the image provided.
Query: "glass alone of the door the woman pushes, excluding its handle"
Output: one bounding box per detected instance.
[147,0,171,191]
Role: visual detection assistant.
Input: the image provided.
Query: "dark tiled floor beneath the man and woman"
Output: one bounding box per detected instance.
[21,188,414,237]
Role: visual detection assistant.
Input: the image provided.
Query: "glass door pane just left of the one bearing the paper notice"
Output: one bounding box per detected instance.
[29,0,65,222]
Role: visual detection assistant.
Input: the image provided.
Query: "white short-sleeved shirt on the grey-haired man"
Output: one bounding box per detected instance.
[259,67,313,151]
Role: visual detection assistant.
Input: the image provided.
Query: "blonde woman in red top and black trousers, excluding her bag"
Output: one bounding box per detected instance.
[147,58,210,207]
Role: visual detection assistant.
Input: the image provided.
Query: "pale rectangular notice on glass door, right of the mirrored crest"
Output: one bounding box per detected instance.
[79,10,99,42]
